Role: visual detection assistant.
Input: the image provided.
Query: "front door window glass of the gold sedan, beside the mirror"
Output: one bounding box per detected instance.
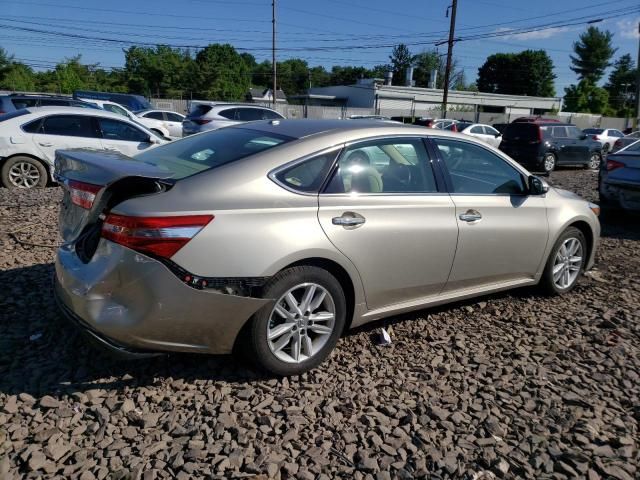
[435,138,527,195]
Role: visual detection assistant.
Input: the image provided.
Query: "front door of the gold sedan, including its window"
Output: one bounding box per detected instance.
[434,138,549,292]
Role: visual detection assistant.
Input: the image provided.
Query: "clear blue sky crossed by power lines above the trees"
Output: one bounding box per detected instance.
[0,0,640,95]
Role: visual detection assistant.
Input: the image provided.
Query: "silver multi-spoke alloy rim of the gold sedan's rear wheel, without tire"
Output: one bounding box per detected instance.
[267,283,336,363]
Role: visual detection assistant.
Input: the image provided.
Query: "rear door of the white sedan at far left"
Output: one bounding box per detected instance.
[33,115,101,164]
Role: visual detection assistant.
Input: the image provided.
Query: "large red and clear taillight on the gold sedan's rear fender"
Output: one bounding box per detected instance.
[102,214,213,258]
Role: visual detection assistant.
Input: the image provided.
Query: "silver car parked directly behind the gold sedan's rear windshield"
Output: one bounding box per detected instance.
[182,101,284,137]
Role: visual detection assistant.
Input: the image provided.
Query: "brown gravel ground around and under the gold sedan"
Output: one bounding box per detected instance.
[0,170,640,480]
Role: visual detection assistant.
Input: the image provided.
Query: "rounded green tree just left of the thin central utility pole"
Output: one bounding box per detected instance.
[194,44,251,100]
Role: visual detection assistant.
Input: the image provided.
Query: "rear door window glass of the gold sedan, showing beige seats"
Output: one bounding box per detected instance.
[326,138,438,194]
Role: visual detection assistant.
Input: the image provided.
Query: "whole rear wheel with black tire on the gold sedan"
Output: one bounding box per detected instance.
[246,266,346,376]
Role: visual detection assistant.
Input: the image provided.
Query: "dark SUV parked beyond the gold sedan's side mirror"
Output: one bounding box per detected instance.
[500,121,602,173]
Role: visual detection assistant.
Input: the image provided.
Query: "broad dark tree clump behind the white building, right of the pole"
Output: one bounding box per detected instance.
[477,50,556,97]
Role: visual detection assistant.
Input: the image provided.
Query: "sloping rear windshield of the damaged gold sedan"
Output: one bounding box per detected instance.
[135,128,294,180]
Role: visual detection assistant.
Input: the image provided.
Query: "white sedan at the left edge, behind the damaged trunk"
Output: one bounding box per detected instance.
[0,107,167,188]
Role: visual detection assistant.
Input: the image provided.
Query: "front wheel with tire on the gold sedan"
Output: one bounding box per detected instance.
[540,227,587,295]
